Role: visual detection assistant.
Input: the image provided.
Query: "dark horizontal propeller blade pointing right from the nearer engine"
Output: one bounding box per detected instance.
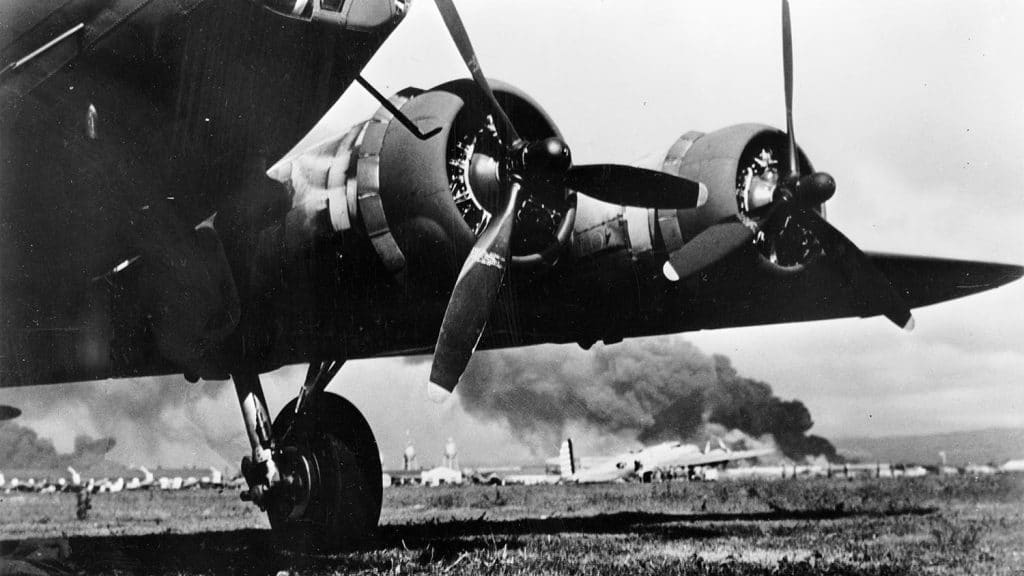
[565,164,708,210]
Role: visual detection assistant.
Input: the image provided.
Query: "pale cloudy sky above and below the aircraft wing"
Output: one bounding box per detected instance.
[0,0,1024,467]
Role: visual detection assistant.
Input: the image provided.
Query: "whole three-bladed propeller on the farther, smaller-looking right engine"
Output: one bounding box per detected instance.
[669,0,913,330]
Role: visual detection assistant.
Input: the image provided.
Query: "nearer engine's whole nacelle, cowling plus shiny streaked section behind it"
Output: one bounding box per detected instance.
[270,80,577,290]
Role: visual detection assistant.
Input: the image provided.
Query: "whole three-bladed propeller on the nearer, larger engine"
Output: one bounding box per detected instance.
[430,0,708,396]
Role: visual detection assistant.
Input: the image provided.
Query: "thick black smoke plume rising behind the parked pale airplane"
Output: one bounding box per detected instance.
[459,337,836,460]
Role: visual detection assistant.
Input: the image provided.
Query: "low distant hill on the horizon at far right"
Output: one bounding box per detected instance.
[834,428,1024,465]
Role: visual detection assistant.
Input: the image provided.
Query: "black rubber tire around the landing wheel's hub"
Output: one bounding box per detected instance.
[267,393,384,552]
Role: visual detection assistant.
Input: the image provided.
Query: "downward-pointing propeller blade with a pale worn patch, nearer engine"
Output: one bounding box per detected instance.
[430,181,520,392]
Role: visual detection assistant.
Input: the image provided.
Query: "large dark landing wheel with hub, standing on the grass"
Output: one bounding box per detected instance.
[267,393,383,551]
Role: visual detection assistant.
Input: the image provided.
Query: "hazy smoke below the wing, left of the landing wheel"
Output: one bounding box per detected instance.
[0,377,248,468]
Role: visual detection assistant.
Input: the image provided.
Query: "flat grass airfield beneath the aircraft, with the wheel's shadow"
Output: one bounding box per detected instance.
[0,476,1024,575]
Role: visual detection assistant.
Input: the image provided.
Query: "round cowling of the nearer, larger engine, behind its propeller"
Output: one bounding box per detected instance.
[378,80,575,272]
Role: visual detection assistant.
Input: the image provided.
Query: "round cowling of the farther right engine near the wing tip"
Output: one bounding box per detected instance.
[663,124,823,271]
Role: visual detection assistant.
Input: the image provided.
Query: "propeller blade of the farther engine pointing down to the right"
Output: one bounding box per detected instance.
[801,210,913,330]
